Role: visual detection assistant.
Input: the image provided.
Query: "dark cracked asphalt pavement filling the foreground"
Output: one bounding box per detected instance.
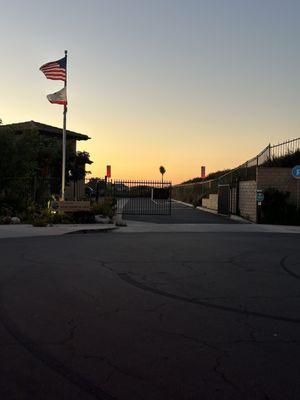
[0,231,300,400]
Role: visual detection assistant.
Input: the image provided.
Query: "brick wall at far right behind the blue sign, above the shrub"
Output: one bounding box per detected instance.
[257,167,300,204]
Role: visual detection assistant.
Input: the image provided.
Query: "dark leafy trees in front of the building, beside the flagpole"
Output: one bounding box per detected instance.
[0,128,91,209]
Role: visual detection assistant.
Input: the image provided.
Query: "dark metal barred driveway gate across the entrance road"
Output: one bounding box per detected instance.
[99,180,172,215]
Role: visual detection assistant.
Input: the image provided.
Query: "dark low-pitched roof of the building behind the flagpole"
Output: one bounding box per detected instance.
[0,121,90,140]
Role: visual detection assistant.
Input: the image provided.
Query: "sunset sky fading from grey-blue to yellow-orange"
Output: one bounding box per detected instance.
[0,0,300,183]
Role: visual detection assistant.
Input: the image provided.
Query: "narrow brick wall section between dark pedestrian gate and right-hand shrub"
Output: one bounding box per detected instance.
[239,181,256,222]
